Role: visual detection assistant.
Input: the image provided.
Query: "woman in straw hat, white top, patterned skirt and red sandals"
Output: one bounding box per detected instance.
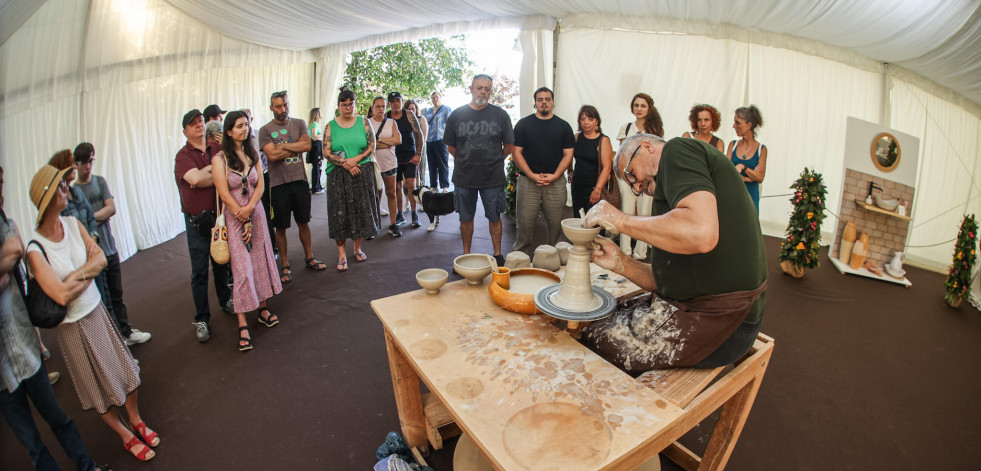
[27,165,160,461]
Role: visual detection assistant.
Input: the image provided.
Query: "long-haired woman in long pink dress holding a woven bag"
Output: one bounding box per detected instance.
[211,111,283,352]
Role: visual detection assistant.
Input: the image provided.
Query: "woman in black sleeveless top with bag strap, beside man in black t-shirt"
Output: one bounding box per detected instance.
[569,105,613,214]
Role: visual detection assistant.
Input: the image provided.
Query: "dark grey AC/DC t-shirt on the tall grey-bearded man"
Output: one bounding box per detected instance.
[443,105,514,189]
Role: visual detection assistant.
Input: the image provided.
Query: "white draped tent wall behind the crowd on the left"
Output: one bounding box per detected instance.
[0,0,314,259]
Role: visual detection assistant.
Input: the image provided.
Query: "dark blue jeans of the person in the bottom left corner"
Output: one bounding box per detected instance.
[0,364,95,471]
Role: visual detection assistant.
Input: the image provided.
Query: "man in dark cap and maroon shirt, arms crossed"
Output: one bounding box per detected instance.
[174,109,235,342]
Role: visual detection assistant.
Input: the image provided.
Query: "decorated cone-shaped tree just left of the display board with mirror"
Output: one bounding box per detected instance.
[780,167,828,268]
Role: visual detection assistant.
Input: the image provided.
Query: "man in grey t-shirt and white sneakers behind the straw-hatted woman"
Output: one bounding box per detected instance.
[73,142,150,346]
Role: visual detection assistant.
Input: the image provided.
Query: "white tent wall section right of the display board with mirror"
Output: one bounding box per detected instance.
[890,79,981,270]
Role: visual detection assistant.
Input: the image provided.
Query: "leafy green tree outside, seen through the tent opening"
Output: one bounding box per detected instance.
[340,36,473,113]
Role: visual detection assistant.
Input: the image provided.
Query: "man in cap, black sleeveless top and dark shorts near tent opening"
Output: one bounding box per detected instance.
[387,92,426,227]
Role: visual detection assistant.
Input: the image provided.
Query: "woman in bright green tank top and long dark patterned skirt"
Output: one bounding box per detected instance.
[324,87,381,271]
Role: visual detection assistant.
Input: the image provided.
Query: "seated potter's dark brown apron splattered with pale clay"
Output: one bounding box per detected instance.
[581,280,766,373]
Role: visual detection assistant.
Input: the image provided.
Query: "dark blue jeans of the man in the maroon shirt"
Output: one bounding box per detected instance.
[184,215,232,322]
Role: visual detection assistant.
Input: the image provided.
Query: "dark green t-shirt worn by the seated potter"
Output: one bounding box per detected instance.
[653,137,767,323]
